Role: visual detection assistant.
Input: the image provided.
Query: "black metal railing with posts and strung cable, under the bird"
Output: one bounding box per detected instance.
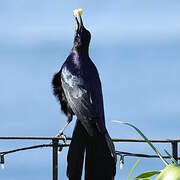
[0,136,180,180]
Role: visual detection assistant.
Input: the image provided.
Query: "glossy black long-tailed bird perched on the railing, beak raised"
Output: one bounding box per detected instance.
[52,12,116,180]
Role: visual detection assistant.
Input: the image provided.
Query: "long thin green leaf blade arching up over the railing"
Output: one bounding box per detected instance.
[113,121,168,166]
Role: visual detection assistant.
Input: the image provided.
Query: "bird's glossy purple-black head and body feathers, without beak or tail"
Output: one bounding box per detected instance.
[52,16,106,135]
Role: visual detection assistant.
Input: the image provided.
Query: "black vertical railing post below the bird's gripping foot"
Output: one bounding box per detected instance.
[52,139,59,180]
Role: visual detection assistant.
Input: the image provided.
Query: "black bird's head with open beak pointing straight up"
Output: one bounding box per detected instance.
[74,11,91,51]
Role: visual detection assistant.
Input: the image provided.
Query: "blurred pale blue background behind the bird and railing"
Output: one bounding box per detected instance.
[0,0,180,180]
